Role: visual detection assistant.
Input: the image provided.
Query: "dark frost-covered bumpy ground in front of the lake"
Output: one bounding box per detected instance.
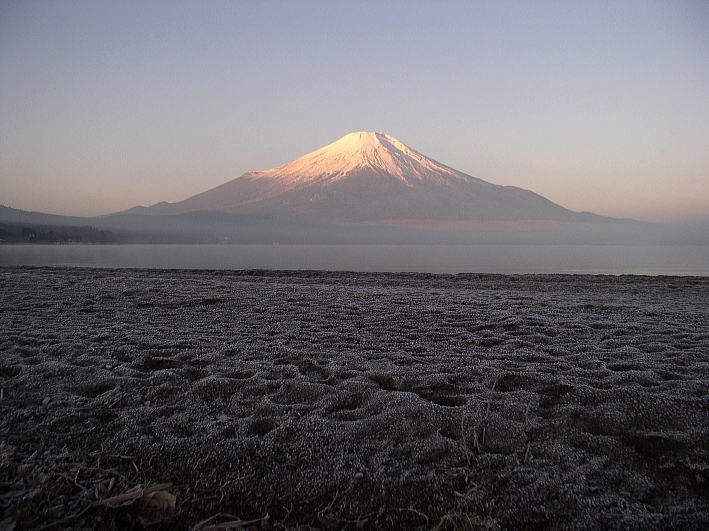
[0,268,709,529]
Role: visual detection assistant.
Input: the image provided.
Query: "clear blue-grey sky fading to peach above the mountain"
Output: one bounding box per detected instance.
[0,0,709,220]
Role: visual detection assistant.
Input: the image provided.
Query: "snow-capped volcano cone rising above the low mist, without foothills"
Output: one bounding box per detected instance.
[125,131,610,228]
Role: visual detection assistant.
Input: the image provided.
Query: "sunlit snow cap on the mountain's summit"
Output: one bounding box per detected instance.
[247,131,471,186]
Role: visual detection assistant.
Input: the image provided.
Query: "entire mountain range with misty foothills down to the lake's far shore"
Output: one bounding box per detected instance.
[0,131,701,243]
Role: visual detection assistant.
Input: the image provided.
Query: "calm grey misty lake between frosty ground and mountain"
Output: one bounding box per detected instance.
[0,244,709,276]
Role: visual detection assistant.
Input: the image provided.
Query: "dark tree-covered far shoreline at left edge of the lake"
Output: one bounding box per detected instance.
[0,222,117,243]
